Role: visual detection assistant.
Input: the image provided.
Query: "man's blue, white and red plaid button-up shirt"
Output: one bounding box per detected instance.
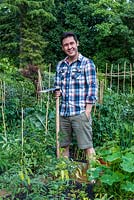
[55,54,98,116]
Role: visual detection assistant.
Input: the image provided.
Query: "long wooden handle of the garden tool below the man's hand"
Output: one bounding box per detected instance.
[56,97,60,158]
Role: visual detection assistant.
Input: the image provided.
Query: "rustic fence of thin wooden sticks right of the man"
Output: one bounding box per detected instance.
[97,63,134,103]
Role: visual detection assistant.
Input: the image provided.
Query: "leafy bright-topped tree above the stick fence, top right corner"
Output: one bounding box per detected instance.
[89,0,134,69]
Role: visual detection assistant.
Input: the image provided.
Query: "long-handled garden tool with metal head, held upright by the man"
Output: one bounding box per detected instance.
[39,87,60,158]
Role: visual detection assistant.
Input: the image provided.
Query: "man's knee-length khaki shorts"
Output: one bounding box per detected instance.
[60,112,93,149]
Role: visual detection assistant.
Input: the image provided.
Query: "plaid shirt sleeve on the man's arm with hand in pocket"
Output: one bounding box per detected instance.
[85,60,98,104]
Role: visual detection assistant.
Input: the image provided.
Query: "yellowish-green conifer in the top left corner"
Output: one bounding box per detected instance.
[0,0,56,67]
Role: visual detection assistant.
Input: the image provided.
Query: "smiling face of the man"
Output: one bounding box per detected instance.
[62,36,78,57]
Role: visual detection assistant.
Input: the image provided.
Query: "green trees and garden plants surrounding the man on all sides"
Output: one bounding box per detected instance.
[0,0,134,200]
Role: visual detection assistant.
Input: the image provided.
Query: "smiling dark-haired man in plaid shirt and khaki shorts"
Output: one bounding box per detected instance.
[55,32,97,159]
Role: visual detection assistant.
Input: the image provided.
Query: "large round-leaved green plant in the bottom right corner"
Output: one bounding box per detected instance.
[87,142,134,200]
